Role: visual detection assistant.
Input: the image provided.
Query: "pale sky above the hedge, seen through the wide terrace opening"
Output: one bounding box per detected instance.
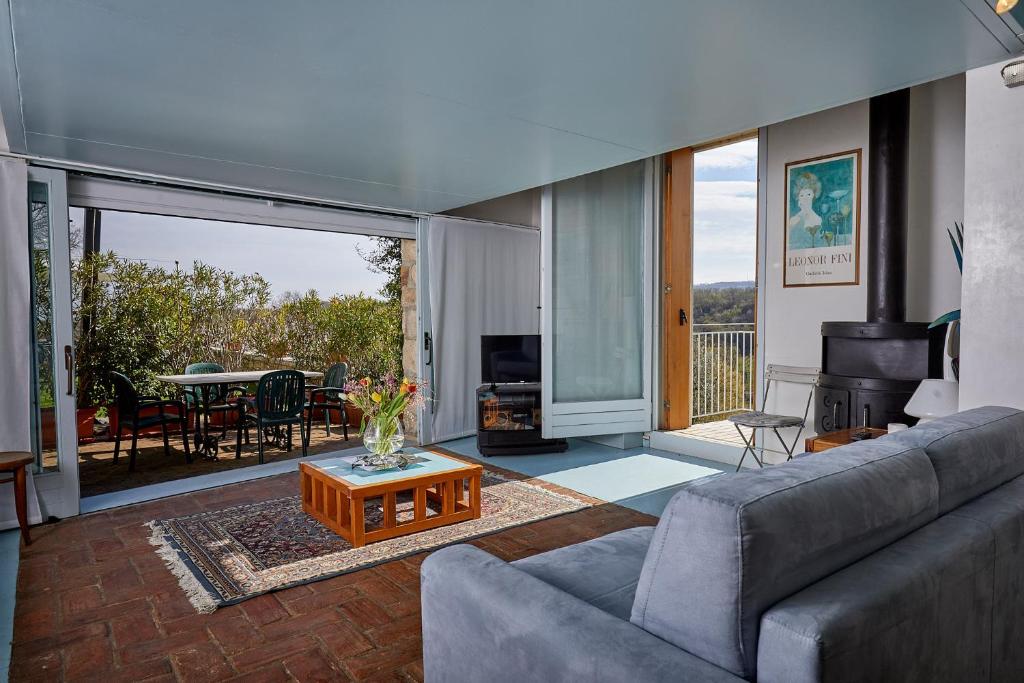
[71,208,385,299]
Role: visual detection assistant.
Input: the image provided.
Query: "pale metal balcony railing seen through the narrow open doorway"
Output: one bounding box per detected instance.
[692,323,756,422]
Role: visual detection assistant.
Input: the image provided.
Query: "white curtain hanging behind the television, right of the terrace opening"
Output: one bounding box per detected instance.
[426,217,541,441]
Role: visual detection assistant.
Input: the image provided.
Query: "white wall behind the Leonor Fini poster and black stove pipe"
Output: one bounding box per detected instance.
[758,76,964,451]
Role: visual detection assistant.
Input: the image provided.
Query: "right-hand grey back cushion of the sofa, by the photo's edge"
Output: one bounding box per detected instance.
[886,405,1024,514]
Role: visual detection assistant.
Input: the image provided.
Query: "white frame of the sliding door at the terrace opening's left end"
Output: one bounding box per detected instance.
[26,166,80,518]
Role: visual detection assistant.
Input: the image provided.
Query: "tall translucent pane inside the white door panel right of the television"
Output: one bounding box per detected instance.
[552,162,644,402]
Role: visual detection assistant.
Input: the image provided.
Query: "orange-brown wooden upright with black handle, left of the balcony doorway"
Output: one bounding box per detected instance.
[658,147,693,430]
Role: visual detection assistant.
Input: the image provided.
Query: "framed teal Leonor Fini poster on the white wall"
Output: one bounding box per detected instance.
[782,150,860,287]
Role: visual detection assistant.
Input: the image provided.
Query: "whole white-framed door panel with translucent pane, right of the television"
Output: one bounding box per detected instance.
[542,160,654,436]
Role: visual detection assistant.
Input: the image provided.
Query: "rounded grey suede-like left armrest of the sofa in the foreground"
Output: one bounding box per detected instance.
[420,545,742,683]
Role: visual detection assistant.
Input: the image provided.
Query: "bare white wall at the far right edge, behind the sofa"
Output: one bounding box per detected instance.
[961,58,1024,410]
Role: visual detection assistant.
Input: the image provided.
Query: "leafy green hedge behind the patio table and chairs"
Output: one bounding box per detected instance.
[72,252,402,405]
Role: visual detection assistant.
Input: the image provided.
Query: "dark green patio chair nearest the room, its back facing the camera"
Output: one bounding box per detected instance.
[234,370,308,464]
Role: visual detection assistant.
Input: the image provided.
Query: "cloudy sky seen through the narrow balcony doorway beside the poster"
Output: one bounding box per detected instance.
[693,138,758,284]
